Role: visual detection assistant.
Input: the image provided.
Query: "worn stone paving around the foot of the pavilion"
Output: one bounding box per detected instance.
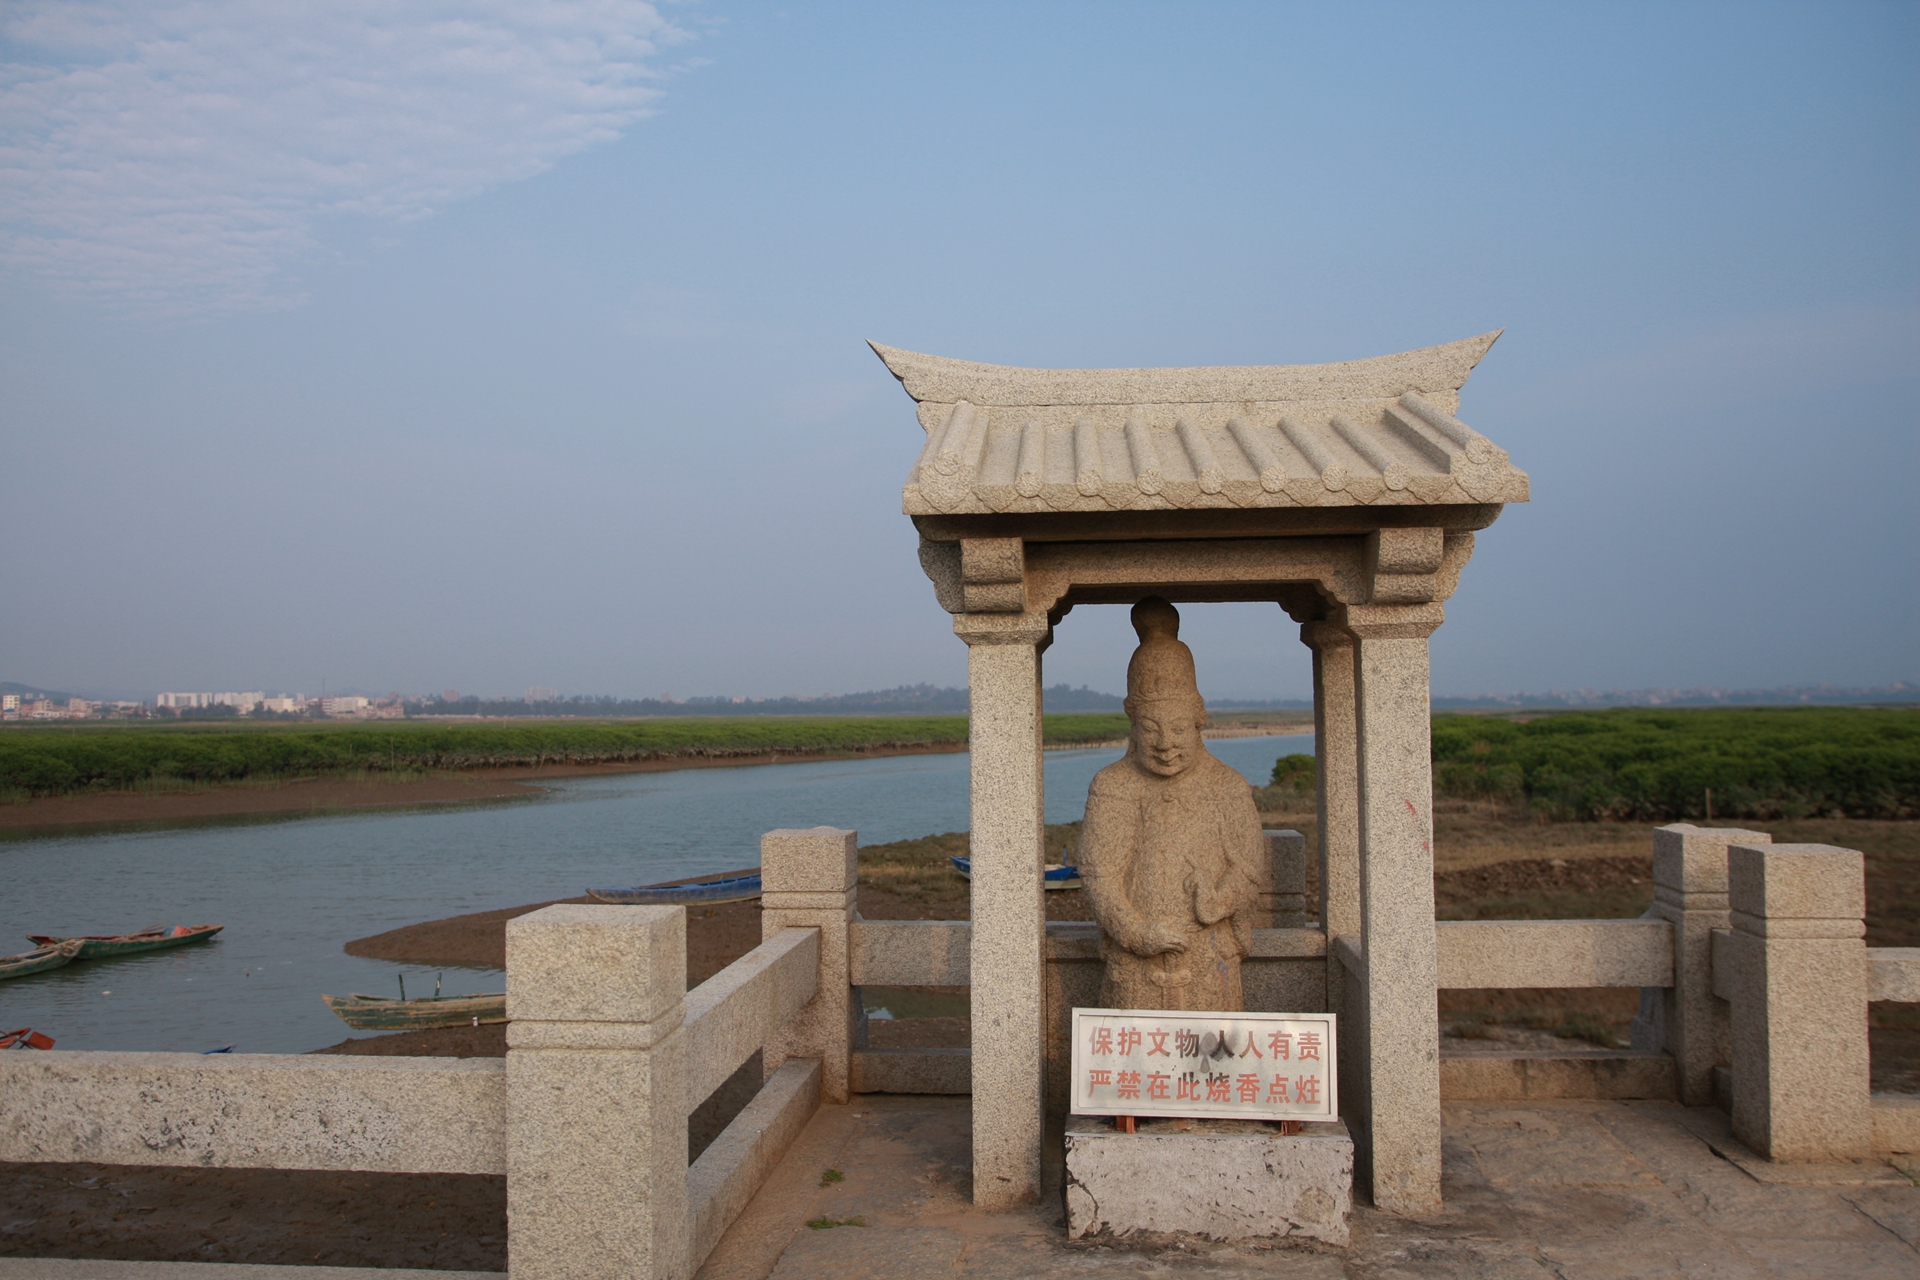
[701,1096,1920,1280]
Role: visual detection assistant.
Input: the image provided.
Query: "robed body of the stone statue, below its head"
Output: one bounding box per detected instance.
[1079,748,1269,1011]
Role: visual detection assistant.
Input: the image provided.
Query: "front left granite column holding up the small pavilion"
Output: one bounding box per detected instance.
[954,616,1046,1209]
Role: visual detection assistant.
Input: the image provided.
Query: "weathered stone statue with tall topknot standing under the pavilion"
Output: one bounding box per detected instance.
[1079,595,1267,1011]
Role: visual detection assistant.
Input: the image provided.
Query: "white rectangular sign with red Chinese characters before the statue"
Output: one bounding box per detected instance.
[1071,1009,1340,1121]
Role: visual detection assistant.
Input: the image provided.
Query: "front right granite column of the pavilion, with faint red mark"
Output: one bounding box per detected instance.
[1342,604,1446,1213]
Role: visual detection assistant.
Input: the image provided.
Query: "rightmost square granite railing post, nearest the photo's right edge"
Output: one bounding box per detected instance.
[1720,844,1874,1163]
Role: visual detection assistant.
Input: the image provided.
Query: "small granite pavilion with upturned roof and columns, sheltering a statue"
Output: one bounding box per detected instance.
[874,332,1526,1211]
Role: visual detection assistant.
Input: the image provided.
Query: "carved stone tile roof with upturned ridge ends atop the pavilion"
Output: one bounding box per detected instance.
[872,330,1526,516]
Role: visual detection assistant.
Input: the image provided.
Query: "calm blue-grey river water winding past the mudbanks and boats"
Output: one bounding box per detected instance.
[0,735,1313,1054]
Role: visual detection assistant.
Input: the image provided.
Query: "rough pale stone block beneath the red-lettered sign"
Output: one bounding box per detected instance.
[1066,1115,1354,1245]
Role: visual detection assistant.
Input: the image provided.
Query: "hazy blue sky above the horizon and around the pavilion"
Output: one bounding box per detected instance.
[0,0,1920,697]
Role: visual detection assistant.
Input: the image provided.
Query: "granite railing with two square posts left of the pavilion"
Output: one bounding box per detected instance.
[0,827,858,1280]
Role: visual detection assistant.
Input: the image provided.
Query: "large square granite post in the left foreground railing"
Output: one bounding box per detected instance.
[507,906,689,1280]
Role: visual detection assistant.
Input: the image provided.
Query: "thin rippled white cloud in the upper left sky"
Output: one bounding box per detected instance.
[0,0,685,313]
